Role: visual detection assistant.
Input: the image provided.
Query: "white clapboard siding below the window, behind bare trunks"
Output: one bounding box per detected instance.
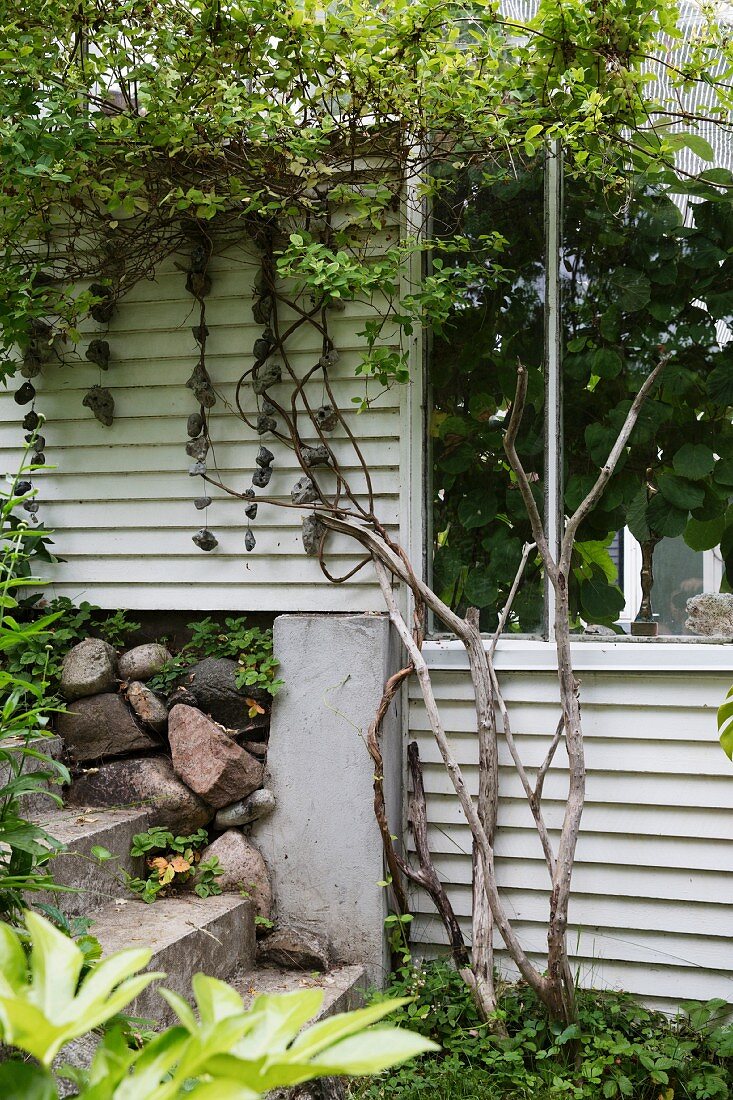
[408,642,733,1008]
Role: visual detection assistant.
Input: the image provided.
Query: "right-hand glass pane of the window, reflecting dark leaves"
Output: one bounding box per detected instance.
[560,174,733,636]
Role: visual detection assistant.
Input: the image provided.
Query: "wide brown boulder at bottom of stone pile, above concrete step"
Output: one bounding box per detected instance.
[67,756,214,834]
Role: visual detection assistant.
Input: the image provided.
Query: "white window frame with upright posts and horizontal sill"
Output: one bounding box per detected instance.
[400,146,733,674]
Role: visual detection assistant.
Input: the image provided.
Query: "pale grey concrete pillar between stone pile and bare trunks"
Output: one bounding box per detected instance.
[253,615,402,983]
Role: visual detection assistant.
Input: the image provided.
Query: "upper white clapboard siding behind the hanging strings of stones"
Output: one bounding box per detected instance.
[0,239,407,612]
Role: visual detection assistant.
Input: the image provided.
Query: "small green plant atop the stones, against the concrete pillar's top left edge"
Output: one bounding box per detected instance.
[150,617,283,699]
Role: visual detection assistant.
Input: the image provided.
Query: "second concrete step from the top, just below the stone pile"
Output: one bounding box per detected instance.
[33,807,147,916]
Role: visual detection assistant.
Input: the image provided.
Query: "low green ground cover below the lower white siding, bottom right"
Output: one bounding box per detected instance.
[352,963,733,1100]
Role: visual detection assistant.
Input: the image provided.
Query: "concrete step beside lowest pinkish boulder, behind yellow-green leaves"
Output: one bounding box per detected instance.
[91,893,255,1024]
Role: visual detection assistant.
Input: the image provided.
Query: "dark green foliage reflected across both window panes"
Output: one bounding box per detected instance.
[431,160,733,630]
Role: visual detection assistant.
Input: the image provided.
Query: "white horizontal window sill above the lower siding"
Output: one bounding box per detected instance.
[423,636,733,675]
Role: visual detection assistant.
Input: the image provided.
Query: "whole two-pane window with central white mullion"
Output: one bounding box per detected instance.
[428,150,733,636]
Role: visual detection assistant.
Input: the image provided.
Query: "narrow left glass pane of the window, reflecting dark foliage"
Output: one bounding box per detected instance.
[428,164,545,633]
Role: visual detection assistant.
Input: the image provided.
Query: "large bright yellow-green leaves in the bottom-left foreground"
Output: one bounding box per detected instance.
[0,913,437,1100]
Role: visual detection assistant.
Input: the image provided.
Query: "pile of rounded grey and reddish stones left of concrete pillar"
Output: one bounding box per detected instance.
[58,638,275,922]
